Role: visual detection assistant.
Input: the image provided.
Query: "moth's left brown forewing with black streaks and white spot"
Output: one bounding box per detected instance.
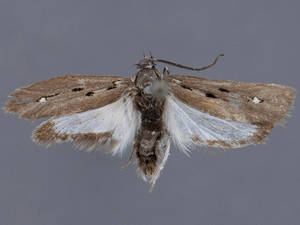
[5,74,133,119]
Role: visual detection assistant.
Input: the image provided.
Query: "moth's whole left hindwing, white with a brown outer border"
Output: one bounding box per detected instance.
[33,95,141,155]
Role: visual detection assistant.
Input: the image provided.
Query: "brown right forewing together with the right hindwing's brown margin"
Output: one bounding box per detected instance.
[167,75,295,148]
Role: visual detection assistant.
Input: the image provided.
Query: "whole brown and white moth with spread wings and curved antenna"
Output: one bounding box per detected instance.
[5,54,295,190]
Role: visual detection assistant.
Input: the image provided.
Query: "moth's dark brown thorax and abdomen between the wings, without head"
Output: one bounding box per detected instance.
[133,67,166,176]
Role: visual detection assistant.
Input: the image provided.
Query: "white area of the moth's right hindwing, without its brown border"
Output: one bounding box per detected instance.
[164,95,257,153]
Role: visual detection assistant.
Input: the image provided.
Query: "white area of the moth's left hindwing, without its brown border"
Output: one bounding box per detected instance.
[53,96,141,155]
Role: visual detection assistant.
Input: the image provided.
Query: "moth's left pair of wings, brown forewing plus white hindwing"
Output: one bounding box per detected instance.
[5,75,140,154]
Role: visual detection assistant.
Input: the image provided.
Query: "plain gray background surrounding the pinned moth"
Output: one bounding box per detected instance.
[0,0,300,225]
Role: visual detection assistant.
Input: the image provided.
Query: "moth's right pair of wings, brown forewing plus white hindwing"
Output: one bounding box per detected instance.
[167,75,295,148]
